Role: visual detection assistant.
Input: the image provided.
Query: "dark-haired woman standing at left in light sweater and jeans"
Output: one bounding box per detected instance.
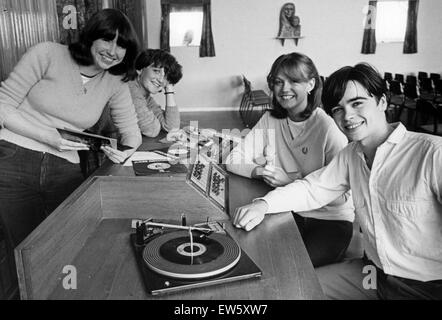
[0,9,141,248]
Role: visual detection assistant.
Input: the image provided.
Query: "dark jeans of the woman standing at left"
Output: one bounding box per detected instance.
[0,140,83,248]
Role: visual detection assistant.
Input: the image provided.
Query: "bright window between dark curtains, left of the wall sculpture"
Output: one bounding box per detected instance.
[169,7,203,47]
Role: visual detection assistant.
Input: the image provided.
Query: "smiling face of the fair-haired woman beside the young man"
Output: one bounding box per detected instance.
[273,71,315,121]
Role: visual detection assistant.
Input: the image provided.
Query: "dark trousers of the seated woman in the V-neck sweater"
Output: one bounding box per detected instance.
[293,213,353,268]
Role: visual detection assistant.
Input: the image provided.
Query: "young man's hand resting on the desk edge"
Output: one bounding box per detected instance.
[232,200,269,231]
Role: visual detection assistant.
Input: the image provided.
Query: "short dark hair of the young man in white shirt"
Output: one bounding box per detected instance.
[322,63,386,115]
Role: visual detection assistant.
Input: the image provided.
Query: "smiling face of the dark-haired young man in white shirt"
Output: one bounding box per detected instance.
[331,81,387,143]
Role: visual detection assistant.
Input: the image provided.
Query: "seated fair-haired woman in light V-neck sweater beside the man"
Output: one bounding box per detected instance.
[227,53,354,267]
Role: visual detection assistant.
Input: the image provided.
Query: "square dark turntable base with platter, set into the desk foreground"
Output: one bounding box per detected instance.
[130,231,262,295]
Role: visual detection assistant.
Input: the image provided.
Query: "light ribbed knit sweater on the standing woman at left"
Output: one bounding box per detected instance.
[0,42,141,163]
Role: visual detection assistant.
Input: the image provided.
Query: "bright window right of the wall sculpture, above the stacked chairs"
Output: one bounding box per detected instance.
[376,1,408,43]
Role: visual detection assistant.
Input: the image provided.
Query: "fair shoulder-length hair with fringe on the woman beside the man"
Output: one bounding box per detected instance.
[267,52,322,119]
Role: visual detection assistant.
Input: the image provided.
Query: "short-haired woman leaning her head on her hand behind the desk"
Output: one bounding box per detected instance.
[80,49,183,177]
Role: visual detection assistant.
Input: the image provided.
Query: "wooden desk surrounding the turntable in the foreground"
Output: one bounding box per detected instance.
[16,112,324,300]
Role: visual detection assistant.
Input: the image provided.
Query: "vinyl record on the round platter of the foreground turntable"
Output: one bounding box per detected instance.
[143,231,241,279]
